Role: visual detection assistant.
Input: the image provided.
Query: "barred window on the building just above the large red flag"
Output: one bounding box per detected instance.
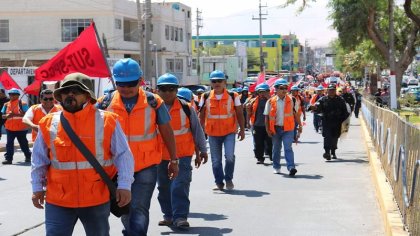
[61,19,92,42]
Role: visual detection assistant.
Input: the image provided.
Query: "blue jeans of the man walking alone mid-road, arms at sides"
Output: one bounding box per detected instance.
[209,133,236,184]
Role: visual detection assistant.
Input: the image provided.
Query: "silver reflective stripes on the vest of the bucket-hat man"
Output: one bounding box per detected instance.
[49,110,113,170]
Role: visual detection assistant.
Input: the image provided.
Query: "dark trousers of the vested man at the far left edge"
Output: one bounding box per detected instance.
[4,130,31,161]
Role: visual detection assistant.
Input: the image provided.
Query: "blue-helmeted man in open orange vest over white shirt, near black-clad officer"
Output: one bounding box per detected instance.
[264,79,302,176]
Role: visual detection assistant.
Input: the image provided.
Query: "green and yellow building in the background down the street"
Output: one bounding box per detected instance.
[192,34,303,74]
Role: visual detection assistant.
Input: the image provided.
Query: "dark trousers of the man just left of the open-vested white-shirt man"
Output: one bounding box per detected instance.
[252,126,273,160]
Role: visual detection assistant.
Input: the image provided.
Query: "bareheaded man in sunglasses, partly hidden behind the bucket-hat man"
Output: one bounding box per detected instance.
[22,89,61,142]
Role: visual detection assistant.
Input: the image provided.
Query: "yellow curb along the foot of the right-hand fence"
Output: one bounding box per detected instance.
[360,115,409,236]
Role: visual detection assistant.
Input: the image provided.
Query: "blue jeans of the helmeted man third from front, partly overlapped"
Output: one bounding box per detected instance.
[158,157,192,220]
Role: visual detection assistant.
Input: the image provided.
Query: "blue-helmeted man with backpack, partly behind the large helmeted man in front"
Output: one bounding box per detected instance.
[157,74,207,229]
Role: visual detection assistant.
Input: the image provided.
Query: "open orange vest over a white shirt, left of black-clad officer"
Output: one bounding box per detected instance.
[268,95,295,134]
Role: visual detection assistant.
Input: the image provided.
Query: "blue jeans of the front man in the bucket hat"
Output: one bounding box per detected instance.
[45,202,109,236]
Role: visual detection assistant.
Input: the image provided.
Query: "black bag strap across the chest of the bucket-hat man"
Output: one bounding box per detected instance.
[60,113,117,199]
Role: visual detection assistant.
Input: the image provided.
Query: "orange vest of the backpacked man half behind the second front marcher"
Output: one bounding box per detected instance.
[160,99,195,160]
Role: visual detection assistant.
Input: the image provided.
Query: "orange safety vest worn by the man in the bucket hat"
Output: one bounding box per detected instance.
[39,104,117,208]
